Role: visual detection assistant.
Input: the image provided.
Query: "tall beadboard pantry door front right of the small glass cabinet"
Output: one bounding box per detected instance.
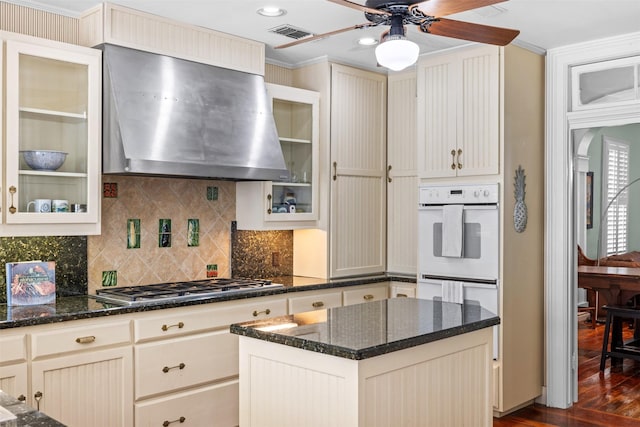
[329,64,387,277]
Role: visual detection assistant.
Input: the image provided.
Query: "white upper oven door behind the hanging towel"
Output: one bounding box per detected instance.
[418,204,500,281]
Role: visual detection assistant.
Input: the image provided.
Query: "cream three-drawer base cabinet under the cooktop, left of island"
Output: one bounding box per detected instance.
[134,296,287,427]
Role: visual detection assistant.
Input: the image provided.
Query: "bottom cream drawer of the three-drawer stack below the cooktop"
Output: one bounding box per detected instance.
[135,380,239,427]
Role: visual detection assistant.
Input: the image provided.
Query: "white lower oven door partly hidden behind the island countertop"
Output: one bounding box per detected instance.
[416,279,500,359]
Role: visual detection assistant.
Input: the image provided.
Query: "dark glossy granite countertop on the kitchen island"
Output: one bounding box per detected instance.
[231,298,500,360]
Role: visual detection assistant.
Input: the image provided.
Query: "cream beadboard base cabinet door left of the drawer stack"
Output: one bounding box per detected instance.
[31,346,133,427]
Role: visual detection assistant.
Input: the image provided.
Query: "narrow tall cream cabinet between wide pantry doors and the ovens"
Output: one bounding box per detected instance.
[386,70,418,275]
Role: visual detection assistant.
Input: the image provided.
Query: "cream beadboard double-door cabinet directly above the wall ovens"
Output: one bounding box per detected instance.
[417,45,501,178]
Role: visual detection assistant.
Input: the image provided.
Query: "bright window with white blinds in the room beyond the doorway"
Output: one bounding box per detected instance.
[602,137,629,256]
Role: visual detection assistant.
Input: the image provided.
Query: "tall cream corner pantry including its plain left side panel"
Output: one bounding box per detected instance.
[293,62,387,277]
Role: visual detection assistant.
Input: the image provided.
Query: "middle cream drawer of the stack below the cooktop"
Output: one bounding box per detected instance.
[134,331,239,399]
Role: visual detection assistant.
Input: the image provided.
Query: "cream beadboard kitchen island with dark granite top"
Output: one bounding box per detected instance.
[231,298,500,427]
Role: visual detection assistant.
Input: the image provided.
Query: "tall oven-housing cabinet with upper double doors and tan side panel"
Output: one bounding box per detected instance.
[417,45,544,415]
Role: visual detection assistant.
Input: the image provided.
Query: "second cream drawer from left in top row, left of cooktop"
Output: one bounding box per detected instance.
[31,320,131,360]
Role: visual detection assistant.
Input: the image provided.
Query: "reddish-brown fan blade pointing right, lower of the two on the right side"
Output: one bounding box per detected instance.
[419,18,520,46]
